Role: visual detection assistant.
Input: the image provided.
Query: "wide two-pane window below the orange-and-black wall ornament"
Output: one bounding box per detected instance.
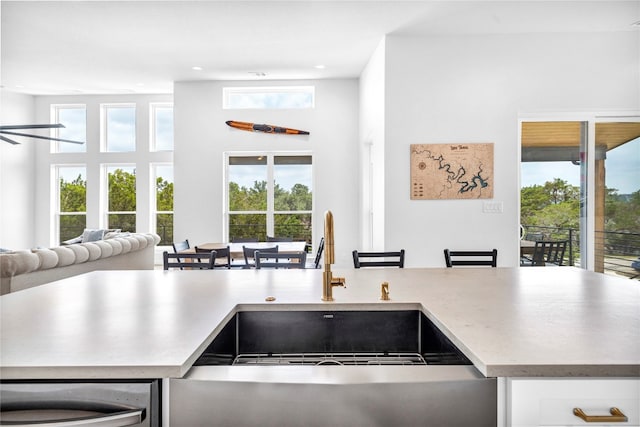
[225,153,313,243]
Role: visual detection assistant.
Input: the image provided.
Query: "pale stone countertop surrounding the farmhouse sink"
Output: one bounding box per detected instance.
[0,267,640,379]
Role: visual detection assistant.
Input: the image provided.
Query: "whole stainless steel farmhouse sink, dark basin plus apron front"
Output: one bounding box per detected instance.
[168,310,497,427]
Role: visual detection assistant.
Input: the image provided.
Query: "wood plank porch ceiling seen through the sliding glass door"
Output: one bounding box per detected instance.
[522,122,640,151]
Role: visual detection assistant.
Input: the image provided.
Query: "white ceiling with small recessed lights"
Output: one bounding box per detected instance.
[0,0,640,94]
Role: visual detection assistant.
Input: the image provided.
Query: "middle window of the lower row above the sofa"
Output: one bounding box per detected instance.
[104,165,136,232]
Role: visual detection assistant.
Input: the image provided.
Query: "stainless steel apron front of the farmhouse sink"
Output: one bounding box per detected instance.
[169,366,497,427]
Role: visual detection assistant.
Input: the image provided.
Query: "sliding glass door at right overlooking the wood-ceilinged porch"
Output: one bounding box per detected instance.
[520,116,640,277]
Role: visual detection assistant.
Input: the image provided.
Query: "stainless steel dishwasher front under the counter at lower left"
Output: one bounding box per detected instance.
[0,380,161,427]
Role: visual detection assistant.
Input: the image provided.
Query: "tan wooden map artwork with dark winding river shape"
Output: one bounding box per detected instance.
[411,143,493,200]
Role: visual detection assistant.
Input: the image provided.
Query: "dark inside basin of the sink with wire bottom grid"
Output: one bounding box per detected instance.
[195,310,471,366]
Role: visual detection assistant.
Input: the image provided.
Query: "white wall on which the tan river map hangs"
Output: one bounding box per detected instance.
[385,32,640,267]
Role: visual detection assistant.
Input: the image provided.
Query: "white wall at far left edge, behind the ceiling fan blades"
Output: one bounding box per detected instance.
[0,90,40,249]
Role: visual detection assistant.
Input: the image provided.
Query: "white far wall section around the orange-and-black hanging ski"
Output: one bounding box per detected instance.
[174,79,359,266]
